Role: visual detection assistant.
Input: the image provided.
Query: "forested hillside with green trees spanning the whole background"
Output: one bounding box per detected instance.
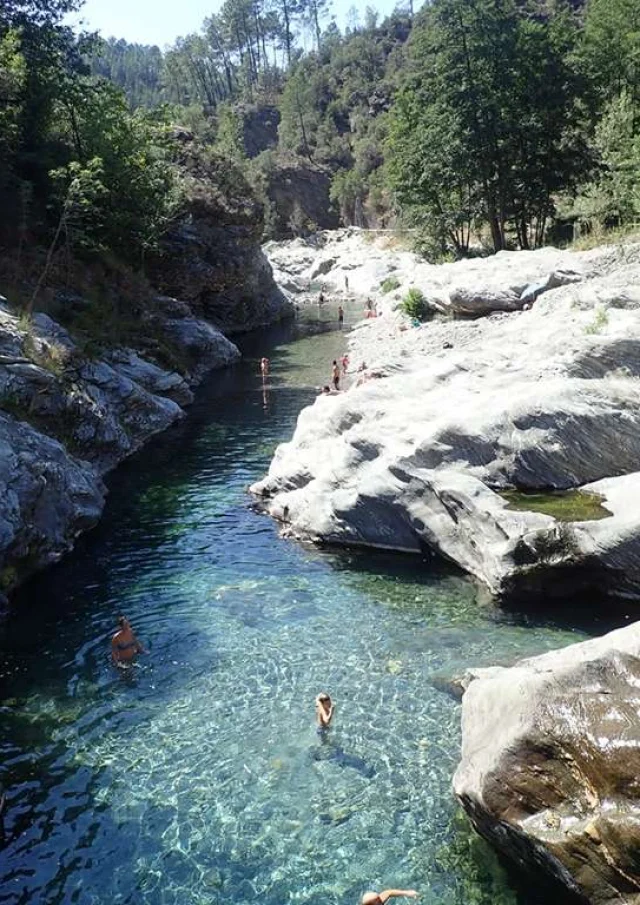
[0,0,640,267]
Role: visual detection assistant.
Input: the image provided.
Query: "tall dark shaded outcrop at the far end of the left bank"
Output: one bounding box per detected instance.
[148,145,293,333]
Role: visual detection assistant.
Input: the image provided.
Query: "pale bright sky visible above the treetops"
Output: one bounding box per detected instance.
[68,0,404,47]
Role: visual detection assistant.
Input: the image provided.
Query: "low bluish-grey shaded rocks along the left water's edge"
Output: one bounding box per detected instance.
[0,299,240,596]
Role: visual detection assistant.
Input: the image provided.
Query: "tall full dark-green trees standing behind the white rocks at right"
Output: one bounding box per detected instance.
[387,0,582,254]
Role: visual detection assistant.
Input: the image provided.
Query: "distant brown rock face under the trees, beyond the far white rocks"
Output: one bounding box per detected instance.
[267,158,340,237]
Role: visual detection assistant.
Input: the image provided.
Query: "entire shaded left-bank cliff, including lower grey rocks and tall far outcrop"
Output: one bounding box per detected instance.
[0,143,293,600]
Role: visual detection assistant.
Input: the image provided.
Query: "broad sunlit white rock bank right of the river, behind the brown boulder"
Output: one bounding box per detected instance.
[253,230,640,601]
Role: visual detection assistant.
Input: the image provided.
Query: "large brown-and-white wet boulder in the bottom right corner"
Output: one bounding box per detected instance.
[453,623,640,905]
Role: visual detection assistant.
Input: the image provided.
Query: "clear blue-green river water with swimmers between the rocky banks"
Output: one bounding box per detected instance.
[0,308,620,905]
